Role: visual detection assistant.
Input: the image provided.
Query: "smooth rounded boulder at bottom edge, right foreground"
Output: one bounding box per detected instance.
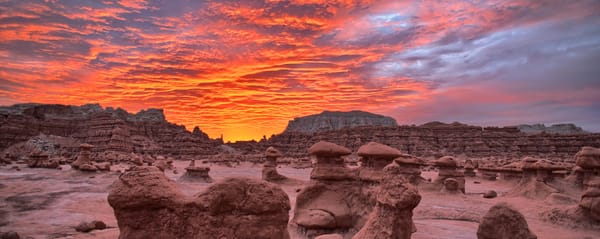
[477,203,537,239]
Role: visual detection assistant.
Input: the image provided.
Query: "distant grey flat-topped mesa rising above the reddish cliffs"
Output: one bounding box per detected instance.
[284,111,398,133]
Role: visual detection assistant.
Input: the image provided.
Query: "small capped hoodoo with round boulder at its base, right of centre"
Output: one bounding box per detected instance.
[433,156,465,193]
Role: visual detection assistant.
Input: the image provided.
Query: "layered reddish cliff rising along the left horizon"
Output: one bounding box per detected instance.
[0,104,220,156]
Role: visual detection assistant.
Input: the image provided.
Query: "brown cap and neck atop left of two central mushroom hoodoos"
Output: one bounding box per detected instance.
[308,141,358,181]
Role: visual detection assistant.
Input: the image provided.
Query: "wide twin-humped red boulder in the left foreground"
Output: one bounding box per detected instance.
[108,166,290,239]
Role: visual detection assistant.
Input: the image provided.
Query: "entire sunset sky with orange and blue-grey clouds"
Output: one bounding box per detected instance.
[0,0,600,141]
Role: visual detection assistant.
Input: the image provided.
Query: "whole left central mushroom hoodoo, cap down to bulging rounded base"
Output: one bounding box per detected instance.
[292,141,375,237]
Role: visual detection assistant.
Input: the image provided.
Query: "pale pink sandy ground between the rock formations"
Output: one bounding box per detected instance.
[0,161,600,239]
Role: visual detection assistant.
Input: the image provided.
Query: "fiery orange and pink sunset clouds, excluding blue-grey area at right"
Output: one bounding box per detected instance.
[0,0,597,140]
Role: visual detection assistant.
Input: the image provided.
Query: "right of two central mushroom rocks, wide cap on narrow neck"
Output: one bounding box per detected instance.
[357,142,402,182]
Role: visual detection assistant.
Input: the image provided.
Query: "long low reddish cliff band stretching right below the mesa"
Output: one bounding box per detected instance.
[258,122,600,158]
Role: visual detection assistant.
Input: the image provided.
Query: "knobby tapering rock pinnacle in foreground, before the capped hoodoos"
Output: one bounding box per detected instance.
[353,164,421,239]
